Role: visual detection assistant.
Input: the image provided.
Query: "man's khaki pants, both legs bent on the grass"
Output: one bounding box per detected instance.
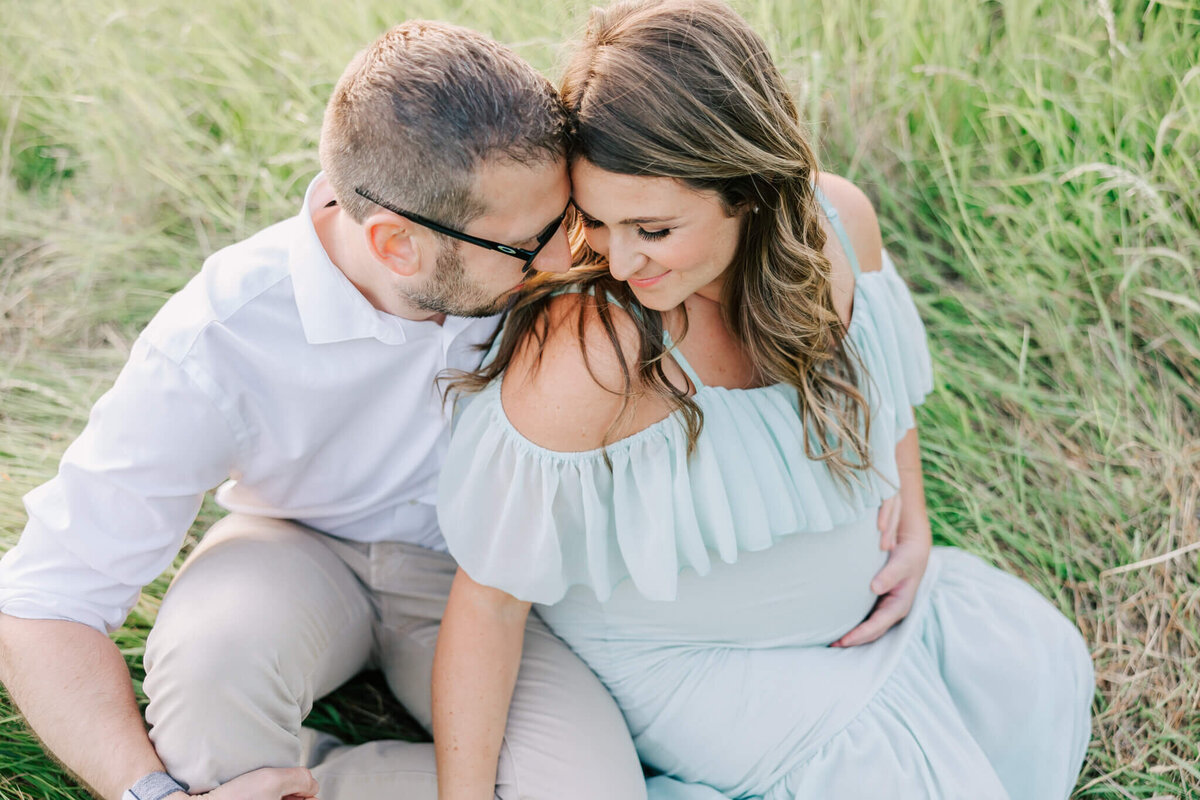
[144,515,646,800]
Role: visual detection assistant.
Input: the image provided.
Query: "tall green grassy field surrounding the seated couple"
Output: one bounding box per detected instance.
[0,0,1200,800]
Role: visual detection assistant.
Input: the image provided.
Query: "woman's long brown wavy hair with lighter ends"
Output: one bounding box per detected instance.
[455,0,870,485]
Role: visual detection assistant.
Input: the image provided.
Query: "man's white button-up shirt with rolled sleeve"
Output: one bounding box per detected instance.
[0,176,503,631]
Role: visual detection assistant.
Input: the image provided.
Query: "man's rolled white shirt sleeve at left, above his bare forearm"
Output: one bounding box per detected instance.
[0,338,238,631]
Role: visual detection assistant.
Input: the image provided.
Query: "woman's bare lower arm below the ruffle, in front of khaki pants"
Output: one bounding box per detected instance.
[433,570,529,800]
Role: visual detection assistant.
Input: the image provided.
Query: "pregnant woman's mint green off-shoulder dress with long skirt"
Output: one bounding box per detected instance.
[439,195,1093,800]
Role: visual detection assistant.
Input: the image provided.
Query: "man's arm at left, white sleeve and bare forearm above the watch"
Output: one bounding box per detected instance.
[0,341,235,800]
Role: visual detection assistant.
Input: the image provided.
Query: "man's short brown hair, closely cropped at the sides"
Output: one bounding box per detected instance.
[320,20,566,228]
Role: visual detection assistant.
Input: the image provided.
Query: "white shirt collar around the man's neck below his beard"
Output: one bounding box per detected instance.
[288,173,496,344]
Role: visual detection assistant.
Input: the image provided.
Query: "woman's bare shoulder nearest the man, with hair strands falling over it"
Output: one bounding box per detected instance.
[500,294,670,452]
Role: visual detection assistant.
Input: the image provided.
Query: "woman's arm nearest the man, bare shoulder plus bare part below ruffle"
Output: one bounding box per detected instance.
[433,294,671,800]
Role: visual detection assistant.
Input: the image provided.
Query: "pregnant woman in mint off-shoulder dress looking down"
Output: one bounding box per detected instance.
[433,0,1092,800]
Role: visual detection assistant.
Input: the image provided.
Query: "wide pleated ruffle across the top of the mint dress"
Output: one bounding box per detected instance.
[438,252,932,603]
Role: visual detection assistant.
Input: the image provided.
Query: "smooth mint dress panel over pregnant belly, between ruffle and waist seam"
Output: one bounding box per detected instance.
[540,513,887,657]
